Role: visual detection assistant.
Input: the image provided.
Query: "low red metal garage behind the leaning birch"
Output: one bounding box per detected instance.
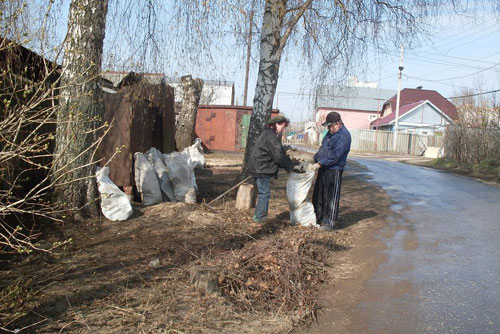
[195,105,279,151]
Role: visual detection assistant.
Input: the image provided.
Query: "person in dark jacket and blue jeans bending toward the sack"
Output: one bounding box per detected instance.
[248,116,300,223]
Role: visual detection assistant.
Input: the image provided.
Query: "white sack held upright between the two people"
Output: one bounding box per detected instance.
[286,164,319,227]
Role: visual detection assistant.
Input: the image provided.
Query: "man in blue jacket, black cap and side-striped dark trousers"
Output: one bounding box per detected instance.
[313,111,351,231]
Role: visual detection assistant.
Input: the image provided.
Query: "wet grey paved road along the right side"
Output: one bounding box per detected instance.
[344,158,500,333]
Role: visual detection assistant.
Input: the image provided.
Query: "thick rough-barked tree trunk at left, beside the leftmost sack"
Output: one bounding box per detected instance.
[53,0,108,218]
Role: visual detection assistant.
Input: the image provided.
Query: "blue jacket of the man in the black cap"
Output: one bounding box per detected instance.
[314,125,351,169]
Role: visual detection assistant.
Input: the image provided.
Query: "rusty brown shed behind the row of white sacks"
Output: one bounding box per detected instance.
[99,80,175,189]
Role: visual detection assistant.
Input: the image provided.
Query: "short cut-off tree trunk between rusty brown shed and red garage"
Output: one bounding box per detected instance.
[175,75,203,151]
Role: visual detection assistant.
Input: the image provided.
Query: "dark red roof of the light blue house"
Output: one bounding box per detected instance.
[382,88,457,119]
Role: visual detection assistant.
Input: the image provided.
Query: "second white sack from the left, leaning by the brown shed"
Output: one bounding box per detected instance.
[134,152,162,205]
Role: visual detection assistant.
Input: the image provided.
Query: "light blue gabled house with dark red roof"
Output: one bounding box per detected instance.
[370,88,457,134]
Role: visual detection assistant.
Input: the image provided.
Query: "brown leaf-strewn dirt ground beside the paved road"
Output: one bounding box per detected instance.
[0,152,390,334]
